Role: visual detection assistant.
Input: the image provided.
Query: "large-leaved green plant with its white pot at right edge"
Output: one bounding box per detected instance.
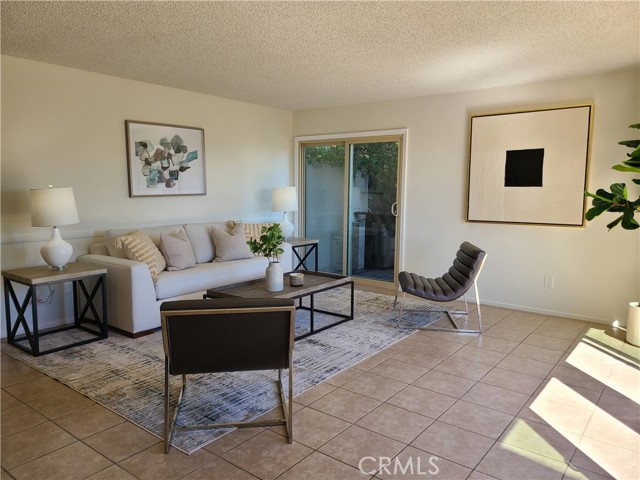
[585,123,640,346]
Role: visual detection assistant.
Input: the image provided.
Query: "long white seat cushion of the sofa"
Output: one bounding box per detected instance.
[155,257,269,300]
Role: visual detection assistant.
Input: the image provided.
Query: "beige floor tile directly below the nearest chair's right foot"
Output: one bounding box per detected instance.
[222,430,313,479]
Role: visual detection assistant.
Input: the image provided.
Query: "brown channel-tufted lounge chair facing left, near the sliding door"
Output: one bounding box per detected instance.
[393,242,487,333]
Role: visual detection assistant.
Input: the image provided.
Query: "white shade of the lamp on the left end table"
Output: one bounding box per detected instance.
[30,186,80,227]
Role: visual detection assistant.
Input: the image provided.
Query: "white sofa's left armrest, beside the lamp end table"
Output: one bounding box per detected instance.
[78,254,160,334]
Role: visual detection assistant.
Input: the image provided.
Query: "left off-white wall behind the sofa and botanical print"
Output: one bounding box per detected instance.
[0,56,293,326]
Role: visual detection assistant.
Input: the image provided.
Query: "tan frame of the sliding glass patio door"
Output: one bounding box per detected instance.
[293,128,409,289]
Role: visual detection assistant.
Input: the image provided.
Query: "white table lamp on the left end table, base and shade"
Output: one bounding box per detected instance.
[30,185,80,270]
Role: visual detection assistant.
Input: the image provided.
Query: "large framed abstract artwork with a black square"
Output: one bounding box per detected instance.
[467,105,593,227]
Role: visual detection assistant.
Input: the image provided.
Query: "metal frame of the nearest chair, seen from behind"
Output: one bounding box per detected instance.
[161,300,295,453]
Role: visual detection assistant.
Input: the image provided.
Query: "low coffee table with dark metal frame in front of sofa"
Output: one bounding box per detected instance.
[204,271,353,340]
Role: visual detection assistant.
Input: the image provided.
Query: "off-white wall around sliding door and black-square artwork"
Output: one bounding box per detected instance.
[294,70,640,322]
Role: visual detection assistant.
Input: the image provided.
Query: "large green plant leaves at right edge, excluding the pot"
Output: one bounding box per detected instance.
[585,123,640,230]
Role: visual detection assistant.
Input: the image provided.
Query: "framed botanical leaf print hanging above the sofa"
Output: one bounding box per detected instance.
[125,120,207,197]
